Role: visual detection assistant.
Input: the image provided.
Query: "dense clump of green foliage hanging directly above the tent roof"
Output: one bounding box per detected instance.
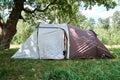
[23,0,79,23]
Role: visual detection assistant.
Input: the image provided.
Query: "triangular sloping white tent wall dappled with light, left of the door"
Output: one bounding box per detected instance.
[12,30,39,59]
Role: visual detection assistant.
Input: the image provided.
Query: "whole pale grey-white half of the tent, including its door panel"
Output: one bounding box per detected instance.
[12,23,70,59]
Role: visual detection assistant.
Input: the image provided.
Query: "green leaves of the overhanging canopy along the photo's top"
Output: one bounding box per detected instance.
[0,0,116,23]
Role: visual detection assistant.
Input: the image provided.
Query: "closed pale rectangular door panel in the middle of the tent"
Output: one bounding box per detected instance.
[37,27,65,59]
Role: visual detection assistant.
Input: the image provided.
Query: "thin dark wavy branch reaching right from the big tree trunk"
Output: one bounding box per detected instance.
[23,0,57,13]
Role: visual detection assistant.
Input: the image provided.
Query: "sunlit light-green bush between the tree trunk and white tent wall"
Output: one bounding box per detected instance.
[12,21,35,44]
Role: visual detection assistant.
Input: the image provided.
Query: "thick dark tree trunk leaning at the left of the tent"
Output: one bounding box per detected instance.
[0,0,24,49]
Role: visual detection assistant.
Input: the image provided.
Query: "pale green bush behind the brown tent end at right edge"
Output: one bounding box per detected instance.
[94,27,120,45]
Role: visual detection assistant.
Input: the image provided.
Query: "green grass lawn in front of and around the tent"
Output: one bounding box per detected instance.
[0,48,120,80]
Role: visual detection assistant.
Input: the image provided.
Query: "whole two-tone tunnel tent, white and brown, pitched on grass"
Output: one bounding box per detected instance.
[12,23,114,59]
